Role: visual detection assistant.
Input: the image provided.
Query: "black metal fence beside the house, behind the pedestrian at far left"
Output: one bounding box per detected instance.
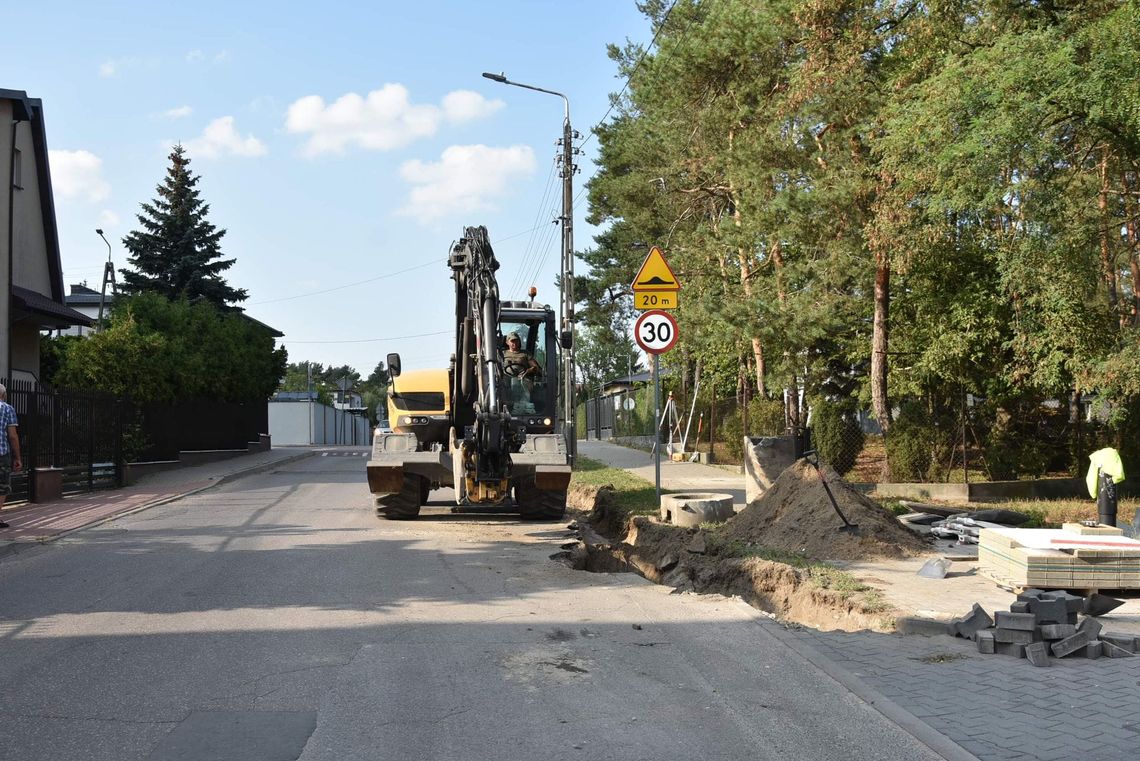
[5,379,129,501]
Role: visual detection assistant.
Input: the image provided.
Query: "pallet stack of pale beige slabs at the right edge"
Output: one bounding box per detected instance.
[978,523,1140,589]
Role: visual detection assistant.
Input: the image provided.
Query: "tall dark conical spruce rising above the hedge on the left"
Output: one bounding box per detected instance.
[122,145,249,308]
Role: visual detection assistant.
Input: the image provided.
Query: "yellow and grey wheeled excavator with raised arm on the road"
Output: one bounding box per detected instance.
[367,227,571,521]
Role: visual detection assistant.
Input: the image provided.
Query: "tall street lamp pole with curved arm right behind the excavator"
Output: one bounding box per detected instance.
[483,72,578,465]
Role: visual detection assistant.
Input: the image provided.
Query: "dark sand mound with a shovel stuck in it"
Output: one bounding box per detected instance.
[724,460,927,560]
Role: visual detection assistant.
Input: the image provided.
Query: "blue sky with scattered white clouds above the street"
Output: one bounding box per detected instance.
[0,0,651,375]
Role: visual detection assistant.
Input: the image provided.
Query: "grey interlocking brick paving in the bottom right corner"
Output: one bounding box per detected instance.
[791,628,1140,761]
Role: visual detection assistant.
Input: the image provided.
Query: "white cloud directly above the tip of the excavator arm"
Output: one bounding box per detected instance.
[398,145,535,222]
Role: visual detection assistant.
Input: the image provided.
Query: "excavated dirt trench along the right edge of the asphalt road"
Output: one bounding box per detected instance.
[552,485,894,631]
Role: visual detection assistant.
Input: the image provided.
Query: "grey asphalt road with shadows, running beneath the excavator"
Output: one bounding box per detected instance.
[0,450,941,761]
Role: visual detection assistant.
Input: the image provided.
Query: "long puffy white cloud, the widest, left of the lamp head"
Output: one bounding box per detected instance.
[285,83,503,156]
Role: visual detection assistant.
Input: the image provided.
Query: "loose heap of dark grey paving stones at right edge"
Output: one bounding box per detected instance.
[950,589,1140,666]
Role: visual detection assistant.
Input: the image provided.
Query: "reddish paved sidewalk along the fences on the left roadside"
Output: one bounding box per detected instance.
[0,447,327,556]
